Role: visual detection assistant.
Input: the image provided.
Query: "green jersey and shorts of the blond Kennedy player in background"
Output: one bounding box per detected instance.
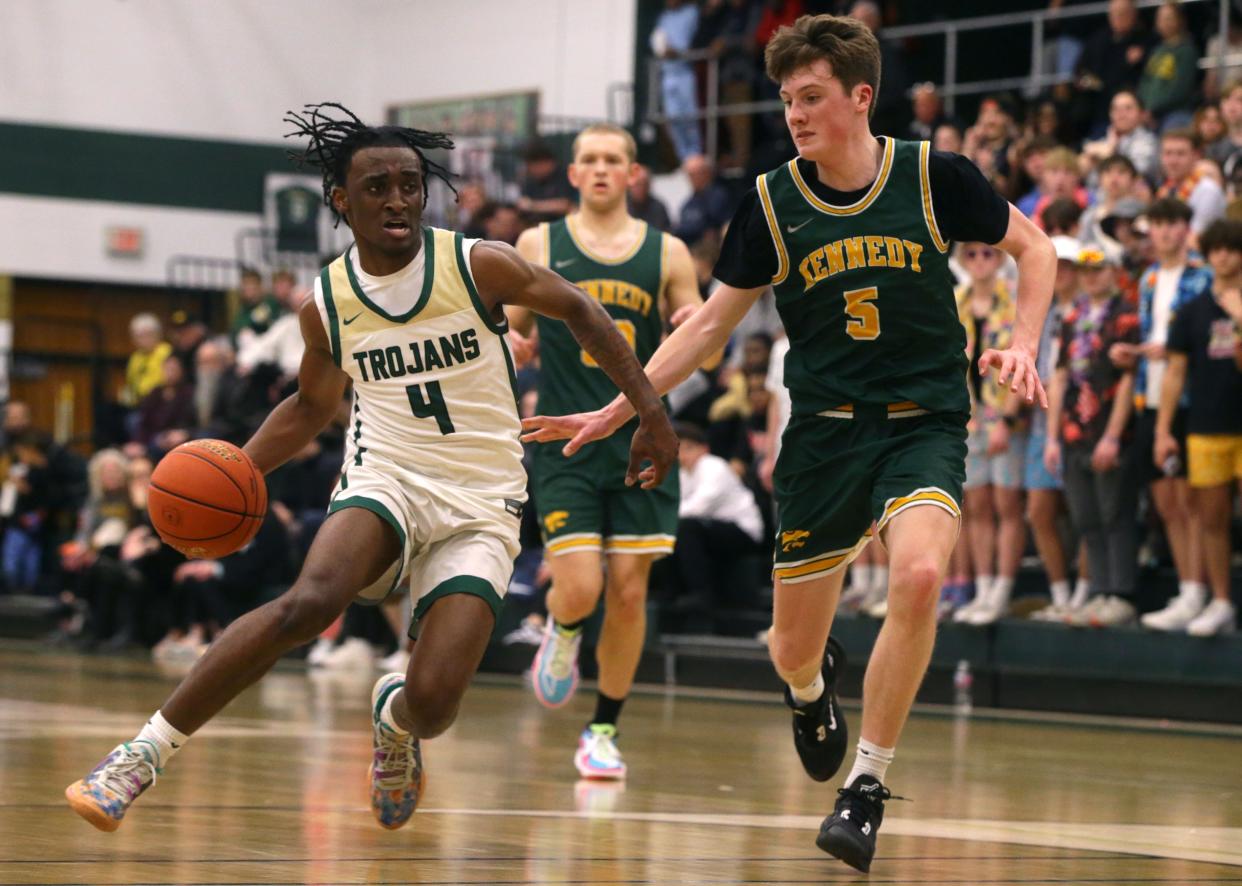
[532,216,678,554]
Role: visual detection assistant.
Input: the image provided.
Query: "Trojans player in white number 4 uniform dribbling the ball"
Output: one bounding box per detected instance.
[66,104,677,830]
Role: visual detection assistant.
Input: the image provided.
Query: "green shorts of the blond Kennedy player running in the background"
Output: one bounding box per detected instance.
[530,437,681,557]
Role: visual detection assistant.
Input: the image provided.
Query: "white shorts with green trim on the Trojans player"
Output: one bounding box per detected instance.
[328,454,523,619]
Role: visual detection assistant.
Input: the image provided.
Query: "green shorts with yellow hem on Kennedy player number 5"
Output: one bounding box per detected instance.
[773,408,968,584]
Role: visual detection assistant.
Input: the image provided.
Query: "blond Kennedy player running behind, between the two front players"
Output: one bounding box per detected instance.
[509,124,703,779]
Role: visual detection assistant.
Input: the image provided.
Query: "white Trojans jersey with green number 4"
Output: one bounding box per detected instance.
[314,227,527,502]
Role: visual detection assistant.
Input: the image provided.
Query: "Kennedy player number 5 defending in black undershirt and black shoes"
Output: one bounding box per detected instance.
[525,15,1056,871]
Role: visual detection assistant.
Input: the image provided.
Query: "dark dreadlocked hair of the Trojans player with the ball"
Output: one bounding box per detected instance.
[284,102,457,222]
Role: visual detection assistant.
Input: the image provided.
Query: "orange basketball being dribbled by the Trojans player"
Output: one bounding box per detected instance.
[147,440,267,559]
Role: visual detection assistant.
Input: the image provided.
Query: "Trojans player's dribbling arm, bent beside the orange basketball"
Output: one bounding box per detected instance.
[242,299,349,473]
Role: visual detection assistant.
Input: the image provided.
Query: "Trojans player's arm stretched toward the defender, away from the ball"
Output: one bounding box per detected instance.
[471,241,677,488]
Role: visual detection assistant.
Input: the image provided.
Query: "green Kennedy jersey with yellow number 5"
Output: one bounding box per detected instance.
[756,138,970,415]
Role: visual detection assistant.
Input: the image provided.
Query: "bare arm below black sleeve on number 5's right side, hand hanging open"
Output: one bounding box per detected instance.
[979,204,1057,409]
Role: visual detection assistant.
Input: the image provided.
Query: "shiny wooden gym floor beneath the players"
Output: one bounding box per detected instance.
[0,641,1242,886]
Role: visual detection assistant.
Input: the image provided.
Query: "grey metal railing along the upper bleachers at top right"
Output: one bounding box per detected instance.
[646,0,1236,160]
